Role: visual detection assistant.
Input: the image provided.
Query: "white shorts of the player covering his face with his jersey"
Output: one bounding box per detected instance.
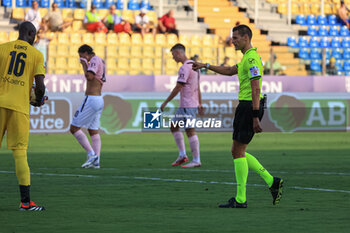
[72,95,104,130]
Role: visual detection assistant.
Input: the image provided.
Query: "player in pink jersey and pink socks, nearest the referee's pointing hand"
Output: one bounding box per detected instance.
[160,44,202,167]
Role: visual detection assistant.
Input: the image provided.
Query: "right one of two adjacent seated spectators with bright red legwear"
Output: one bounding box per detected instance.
[103,5,131,34]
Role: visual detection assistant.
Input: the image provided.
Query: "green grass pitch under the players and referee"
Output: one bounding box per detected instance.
[0,133,350,233]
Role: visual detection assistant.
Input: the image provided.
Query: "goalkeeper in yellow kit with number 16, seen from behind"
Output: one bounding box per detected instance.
[0,22,45,211]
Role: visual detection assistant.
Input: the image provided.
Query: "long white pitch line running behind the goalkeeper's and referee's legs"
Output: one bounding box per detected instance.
[0,171,350,193]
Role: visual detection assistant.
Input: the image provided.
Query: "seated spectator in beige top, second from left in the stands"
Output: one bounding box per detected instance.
[44,2,73,32]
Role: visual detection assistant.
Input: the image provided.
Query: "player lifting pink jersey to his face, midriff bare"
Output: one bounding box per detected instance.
[70,45,106,168]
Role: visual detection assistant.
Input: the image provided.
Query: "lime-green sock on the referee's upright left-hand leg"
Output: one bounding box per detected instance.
[233,157,248,203]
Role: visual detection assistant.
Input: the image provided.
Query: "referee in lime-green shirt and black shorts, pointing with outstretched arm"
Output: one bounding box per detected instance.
[192,25,283,208]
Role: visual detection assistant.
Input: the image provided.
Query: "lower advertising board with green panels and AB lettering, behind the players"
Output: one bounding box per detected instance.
[31,92,350,134]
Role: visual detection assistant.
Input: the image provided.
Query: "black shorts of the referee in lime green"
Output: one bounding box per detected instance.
[232,99,264,144]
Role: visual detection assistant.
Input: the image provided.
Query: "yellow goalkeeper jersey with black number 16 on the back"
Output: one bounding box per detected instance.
[0,40,45,115]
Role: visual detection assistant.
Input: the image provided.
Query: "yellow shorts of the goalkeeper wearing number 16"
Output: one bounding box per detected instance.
[0,107,29,150]
